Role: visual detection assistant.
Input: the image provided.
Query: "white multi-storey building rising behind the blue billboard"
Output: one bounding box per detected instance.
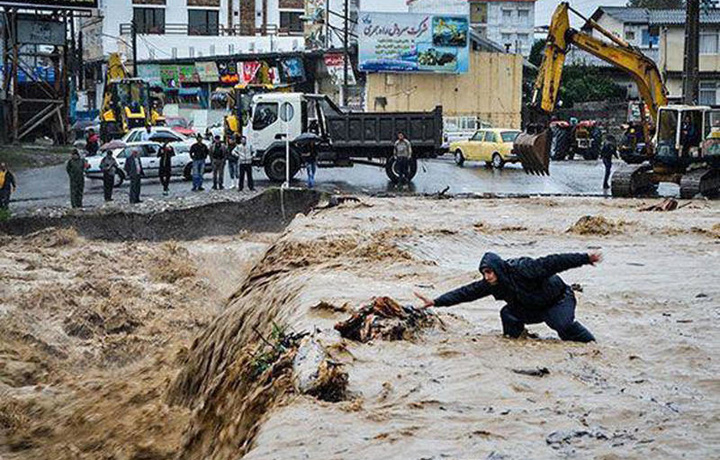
[408,0,535,56]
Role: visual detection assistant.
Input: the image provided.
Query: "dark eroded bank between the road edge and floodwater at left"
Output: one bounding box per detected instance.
[0,189,322,241]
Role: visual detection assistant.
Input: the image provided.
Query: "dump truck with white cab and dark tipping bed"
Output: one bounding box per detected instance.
[243,93,443,182]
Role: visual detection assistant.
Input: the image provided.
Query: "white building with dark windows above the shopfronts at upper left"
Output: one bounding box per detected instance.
[81,0,304,61]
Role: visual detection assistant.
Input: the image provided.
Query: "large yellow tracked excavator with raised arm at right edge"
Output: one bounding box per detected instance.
[515,2,720,198]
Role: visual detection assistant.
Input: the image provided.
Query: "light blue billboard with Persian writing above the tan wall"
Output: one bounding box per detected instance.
[357,12,470,73]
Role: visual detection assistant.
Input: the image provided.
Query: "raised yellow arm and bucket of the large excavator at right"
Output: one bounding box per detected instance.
[516,2,667,174]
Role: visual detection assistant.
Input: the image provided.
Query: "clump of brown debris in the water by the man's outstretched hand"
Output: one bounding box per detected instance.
[335,297,436,342]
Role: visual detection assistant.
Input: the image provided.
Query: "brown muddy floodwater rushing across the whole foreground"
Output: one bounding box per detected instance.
[0,197,720,460]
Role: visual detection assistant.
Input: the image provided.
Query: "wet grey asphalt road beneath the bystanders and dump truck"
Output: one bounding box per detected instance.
[11,155,678,210]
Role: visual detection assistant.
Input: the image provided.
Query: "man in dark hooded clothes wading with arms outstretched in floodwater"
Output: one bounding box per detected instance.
[415,252,602,342]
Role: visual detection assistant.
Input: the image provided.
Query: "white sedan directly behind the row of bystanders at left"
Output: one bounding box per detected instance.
[85,142,212,187]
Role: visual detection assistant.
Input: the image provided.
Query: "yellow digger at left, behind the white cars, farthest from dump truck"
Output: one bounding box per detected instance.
[100,53,165,142]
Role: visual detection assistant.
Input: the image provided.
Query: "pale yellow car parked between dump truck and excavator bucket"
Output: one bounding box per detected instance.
[450,128,520,169]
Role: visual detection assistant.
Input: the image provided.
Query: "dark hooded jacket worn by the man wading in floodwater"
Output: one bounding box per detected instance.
[435,252,590,312]
